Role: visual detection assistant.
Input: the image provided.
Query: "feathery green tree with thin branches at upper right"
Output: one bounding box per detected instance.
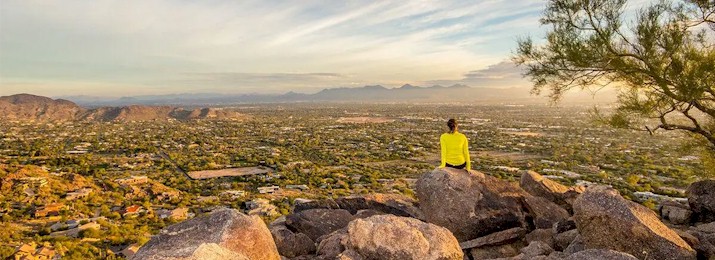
[513,0,715,174]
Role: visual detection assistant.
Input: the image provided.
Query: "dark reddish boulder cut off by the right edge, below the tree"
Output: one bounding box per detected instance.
[686,180,715,222]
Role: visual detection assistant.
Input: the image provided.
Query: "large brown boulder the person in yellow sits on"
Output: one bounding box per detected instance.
[417,168,528,241]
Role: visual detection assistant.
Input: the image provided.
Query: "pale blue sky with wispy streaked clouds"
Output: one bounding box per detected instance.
[0,0,546,97]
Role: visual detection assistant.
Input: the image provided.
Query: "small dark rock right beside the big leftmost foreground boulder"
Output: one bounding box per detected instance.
[270,225,315,258]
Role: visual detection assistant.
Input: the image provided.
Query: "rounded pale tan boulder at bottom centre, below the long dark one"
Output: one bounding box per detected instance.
[318,215,463,260]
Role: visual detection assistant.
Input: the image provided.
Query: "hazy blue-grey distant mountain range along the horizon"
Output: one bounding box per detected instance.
[59,84,608,106]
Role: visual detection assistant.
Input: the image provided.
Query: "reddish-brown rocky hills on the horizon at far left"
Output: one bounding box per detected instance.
[0,94,243,122]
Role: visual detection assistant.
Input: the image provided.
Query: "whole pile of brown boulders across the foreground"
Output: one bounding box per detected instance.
[133,169,715,260]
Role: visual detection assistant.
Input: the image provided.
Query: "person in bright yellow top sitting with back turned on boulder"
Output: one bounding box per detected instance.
[439,119,472,170]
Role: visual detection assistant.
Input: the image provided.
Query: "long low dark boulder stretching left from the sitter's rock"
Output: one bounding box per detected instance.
[293,193,424,219]
